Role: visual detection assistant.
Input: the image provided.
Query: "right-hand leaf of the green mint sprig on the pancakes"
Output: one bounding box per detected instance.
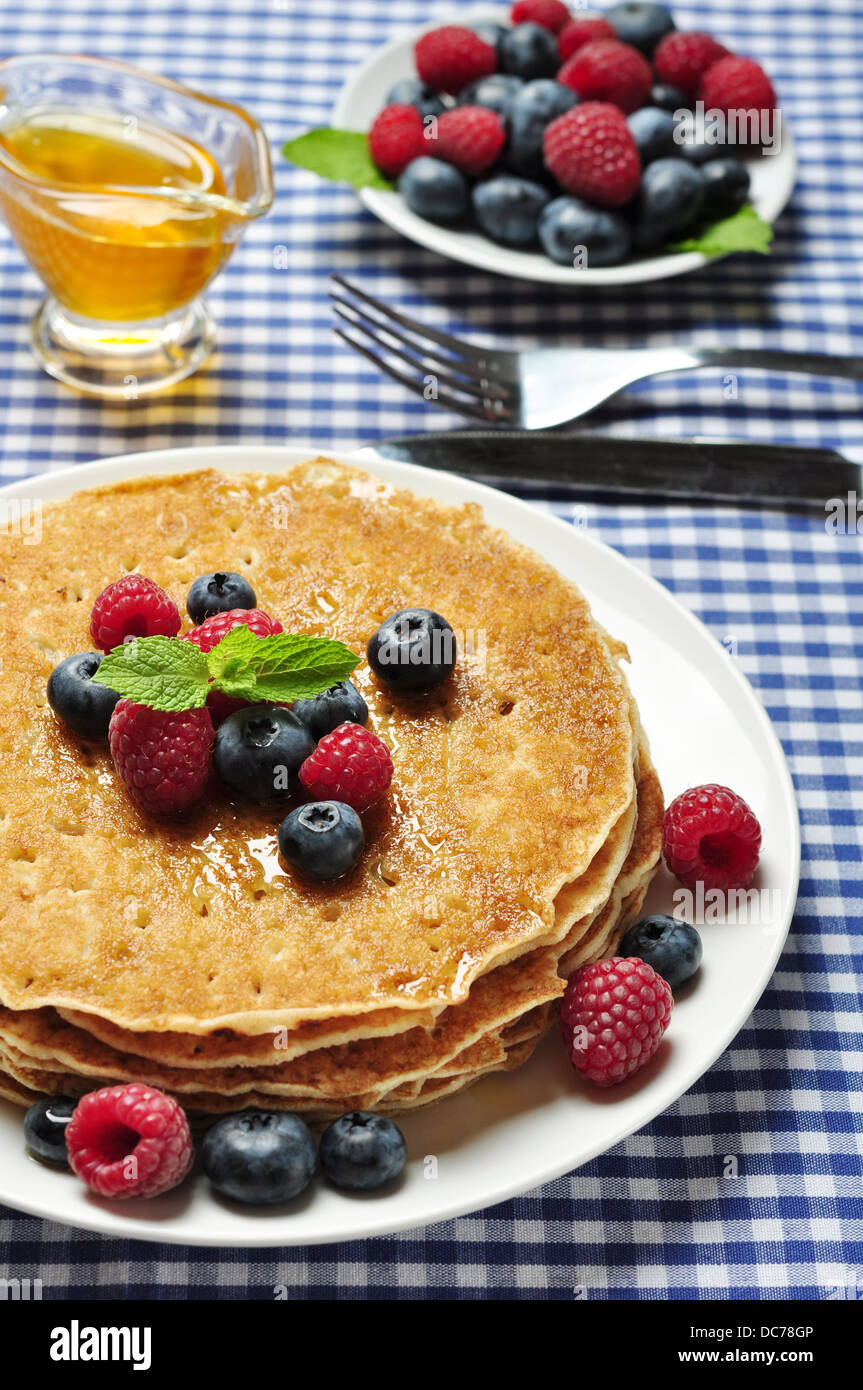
[207,627,360,702]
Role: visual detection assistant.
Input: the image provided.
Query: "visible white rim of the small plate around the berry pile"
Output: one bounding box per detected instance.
[332,6,798,291]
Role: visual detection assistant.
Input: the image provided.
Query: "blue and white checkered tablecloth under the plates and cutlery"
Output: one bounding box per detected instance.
[0,0,863,1300]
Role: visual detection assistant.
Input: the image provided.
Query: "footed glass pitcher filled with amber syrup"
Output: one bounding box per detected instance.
[0,54,272,400]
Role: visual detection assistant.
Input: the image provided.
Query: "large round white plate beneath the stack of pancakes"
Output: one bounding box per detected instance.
[0,445,799,1247]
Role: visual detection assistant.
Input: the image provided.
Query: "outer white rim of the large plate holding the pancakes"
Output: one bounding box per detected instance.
[0,443,800,1248]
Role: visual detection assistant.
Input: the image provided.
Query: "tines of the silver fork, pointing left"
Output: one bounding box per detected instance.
[329,275,518,423]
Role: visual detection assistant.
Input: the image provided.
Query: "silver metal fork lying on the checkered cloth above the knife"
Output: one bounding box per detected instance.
[329,275,863,430]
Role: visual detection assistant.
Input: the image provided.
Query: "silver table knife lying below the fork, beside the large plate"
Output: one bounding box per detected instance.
[361,430,863,511]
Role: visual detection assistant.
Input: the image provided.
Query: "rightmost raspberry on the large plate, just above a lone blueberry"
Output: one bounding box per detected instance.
[663,783,762,891]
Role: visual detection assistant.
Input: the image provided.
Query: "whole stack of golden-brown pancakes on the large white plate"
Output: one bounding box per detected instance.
[0,459,663,1119]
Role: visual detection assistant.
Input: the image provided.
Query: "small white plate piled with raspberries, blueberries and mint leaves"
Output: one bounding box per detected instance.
[285,0,796,286]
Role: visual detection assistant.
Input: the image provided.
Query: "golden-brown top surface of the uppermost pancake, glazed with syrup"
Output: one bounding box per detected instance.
[0,461,634,1033]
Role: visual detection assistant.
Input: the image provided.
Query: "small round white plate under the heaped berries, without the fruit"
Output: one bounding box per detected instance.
[332,6,798,289]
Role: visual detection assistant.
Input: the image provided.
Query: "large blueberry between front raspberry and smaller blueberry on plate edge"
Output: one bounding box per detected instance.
[200,1111,315,1207]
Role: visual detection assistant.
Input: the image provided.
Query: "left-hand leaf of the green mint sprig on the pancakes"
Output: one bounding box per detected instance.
[93,637,210,713]
